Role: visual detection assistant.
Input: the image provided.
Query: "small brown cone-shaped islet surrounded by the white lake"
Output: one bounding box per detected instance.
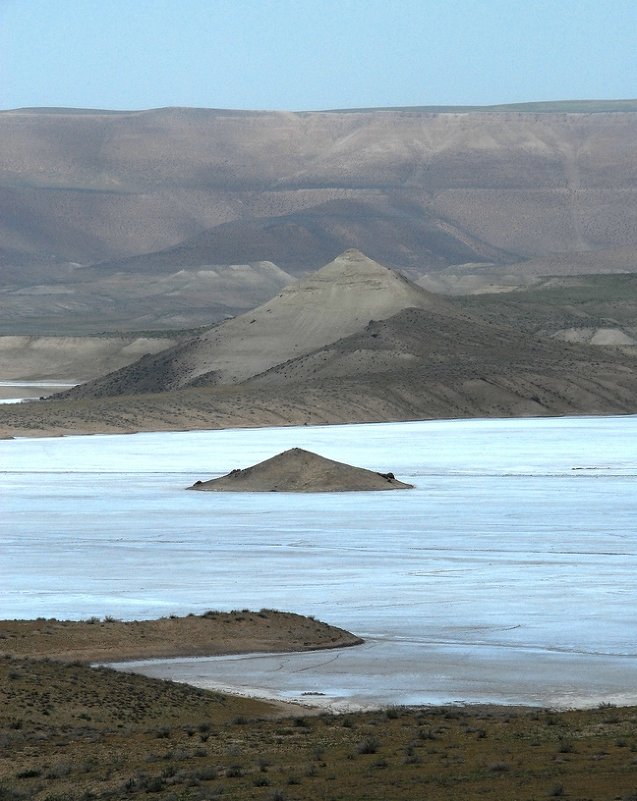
[189,448,412,492]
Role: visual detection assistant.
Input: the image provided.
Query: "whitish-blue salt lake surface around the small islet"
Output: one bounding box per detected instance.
[0,416,637,708]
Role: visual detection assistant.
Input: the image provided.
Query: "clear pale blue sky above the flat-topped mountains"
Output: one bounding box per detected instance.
[0,0,637,110]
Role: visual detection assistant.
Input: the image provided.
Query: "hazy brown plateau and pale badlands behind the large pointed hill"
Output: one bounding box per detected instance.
[0,101,637,335]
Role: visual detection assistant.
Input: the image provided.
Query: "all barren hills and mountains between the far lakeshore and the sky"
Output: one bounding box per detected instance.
[0,100,637,436]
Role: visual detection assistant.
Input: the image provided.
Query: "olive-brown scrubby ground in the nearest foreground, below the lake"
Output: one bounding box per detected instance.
[0,613,637,801]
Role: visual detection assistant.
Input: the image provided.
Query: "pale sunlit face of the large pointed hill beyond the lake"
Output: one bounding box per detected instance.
[56,250,466,397]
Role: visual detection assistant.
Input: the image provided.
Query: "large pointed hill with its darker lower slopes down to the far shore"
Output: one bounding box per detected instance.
[0,250,637,436]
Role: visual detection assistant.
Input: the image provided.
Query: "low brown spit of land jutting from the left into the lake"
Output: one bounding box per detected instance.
[0,609,362,663]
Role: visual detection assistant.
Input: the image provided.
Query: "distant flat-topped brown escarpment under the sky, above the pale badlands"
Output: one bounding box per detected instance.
[0,105,637,271]
